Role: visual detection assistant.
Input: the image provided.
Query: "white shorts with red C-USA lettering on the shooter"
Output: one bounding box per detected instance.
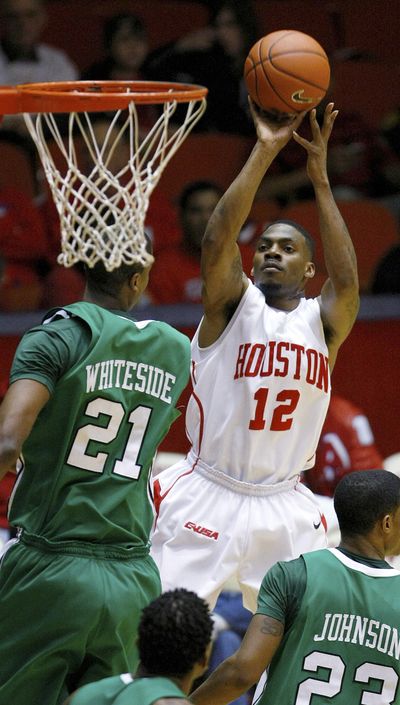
[151,458,327,612]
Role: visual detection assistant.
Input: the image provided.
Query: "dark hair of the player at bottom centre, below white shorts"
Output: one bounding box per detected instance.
[138,588,213,677]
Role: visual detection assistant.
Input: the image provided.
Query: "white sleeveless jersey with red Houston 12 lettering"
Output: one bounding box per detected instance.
[186,282,330,484]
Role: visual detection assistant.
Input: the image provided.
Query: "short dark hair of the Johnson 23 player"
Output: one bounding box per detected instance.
[333,470,400,535]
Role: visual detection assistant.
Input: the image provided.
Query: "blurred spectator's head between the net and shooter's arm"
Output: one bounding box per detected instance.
[179,181,223,256]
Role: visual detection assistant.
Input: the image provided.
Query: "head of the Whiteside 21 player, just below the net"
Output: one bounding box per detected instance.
[85,234,153,311]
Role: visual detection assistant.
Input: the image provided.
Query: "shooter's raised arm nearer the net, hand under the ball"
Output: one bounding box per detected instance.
[201,104,304,338]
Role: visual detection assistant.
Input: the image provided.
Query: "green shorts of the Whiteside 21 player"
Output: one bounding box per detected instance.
[0,542,161,705]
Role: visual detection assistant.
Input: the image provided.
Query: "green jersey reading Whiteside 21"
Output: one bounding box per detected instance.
[9,302,190,547]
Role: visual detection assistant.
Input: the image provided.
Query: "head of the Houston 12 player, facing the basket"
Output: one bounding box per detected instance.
[252,220,315,297]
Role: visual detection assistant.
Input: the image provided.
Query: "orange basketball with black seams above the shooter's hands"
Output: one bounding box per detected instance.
[244,29,330,113]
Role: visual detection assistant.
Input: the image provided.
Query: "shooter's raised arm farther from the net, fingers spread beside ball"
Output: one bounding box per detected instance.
[293,103,359,369]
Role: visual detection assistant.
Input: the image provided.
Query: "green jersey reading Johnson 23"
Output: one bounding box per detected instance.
[254,549,400,705]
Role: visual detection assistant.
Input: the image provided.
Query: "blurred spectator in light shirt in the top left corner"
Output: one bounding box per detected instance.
[0,0,78,85]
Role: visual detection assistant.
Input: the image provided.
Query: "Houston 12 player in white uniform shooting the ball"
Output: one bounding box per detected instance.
[152,103,359,611]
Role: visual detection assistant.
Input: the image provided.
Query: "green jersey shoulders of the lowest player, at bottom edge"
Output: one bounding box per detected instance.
[71,673,186,705]
